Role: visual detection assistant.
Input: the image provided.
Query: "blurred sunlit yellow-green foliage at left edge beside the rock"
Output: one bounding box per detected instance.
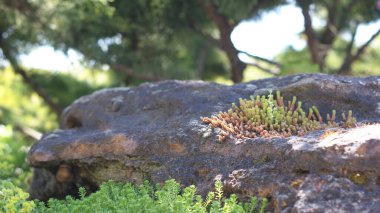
[0,68,113,190]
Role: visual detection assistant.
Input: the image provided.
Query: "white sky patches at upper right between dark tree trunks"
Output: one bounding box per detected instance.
[231,5,380,59]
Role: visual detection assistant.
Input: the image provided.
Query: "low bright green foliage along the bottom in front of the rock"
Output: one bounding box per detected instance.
[0,180,268,213]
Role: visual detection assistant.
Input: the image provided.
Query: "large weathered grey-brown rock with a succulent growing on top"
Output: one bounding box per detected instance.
[28,74,380,212]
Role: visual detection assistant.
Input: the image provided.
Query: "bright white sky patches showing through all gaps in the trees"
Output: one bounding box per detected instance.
[21,5,380,71]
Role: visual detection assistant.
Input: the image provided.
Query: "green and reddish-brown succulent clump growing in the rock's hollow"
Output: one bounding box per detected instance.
[201,91,356,141]
